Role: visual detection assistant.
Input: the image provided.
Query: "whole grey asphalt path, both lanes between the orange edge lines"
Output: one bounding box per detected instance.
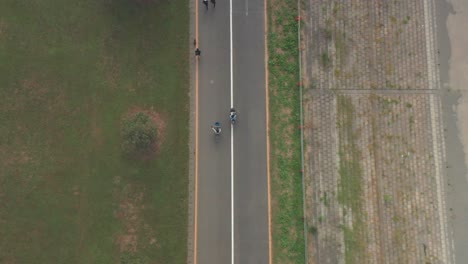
[197,0,269,264]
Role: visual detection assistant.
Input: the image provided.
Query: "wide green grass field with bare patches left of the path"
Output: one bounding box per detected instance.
[0,0,189,263]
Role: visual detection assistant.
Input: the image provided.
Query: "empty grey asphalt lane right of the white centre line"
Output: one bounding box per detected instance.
[233,0,268,264]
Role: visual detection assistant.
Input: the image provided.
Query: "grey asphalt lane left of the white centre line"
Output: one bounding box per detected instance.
[197,1,231,264]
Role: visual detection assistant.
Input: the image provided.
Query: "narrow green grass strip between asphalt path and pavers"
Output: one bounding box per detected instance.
[268,0,305,264]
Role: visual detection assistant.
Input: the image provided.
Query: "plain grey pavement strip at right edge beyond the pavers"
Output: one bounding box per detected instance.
[437,0,468,263]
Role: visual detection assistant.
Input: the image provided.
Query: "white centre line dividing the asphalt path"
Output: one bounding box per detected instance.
[229,0,234,264]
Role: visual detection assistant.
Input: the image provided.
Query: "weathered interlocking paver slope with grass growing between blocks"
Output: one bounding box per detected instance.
[302,0,453,264]
